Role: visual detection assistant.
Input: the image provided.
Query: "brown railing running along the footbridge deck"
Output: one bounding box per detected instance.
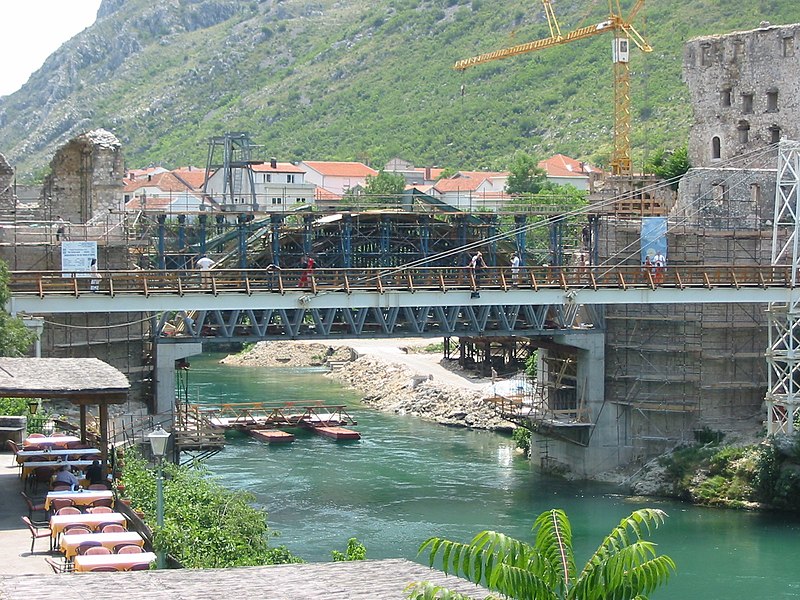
[9,265,792,298]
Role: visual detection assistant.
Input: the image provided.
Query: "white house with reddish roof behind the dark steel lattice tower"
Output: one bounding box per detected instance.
[206,160,316,212]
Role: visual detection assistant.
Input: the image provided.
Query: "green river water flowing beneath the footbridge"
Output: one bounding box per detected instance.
[194,355,800,600]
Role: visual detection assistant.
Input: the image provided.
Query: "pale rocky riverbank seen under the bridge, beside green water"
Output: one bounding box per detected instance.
[222,342,514,431]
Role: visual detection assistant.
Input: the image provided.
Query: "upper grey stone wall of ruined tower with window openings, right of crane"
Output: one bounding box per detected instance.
[683,24,800,168]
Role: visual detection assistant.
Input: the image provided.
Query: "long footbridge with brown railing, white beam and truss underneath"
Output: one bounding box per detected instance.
[8,265,800,343]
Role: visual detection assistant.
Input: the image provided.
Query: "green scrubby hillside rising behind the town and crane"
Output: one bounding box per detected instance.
[0,0,800,177]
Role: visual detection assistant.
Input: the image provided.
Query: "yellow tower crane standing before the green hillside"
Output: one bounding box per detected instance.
[453,0,653,177]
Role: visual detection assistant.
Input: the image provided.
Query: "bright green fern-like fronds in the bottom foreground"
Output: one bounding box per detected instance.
[409,508,675,600]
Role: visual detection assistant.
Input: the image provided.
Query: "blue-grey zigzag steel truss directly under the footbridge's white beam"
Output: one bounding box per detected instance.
[155,304,600,343]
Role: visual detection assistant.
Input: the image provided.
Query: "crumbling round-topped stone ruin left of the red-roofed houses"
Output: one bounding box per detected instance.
[44,129,125,225]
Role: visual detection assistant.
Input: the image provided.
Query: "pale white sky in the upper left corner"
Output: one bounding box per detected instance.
[0,0,101,96]
